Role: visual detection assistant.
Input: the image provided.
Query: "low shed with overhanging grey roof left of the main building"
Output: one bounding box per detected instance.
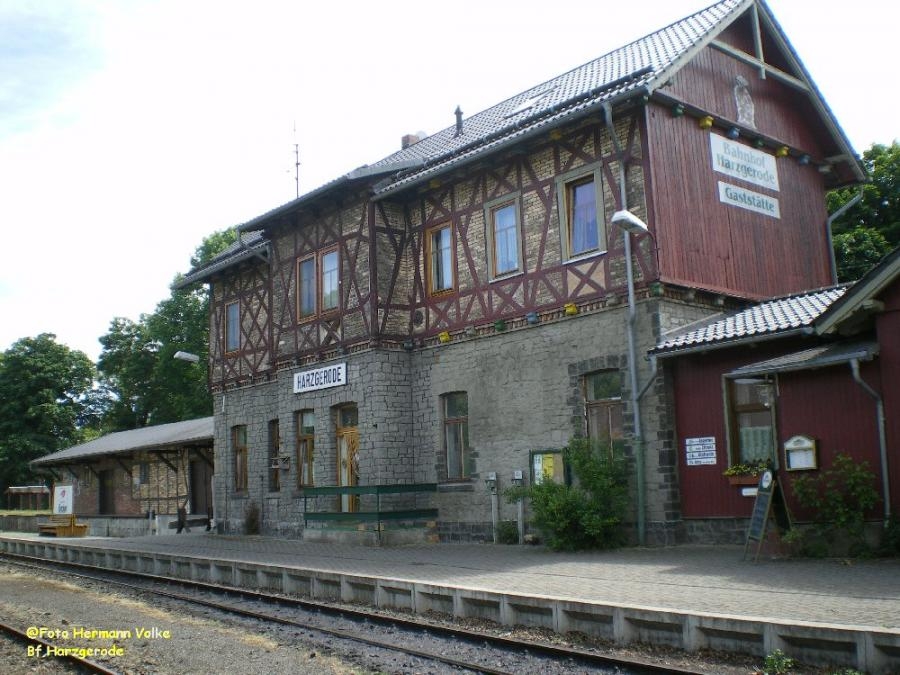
[31,417,213,536]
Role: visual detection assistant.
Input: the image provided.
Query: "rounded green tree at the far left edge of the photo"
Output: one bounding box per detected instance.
[0,333,95,494]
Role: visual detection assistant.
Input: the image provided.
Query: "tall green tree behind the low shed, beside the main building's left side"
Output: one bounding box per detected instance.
[97,230,235,431]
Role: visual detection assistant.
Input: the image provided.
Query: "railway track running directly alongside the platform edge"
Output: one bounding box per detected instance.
[0,553,702,675]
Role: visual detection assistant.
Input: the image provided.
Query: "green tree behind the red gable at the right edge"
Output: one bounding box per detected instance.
[828,141,900,281]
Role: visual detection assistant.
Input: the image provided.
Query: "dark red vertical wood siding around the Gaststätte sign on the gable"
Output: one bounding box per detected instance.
[647,99,831,298]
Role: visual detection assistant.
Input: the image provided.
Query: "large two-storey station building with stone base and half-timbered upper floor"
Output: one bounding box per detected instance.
[183,0,864,543]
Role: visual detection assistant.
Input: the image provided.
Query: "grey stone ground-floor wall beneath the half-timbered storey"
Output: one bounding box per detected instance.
[207,299,720,543]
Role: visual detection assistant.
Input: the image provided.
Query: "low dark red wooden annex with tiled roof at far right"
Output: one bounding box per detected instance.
[653,249,900,541]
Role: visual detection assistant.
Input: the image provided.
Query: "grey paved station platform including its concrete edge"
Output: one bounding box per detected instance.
[0,533,900,673]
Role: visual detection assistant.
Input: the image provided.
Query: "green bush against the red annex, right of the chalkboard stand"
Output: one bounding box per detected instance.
[794,454,880,554]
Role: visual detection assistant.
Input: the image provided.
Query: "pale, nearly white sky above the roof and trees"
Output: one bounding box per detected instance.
[0,0,900,359]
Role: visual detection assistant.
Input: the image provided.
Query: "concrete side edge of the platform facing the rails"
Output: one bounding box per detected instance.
[0,537,900,675]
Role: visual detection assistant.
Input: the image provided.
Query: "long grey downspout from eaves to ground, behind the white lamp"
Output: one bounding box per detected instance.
[603,103,647,546]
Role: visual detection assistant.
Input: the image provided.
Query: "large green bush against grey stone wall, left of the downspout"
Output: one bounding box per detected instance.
[504,438,628,551]
